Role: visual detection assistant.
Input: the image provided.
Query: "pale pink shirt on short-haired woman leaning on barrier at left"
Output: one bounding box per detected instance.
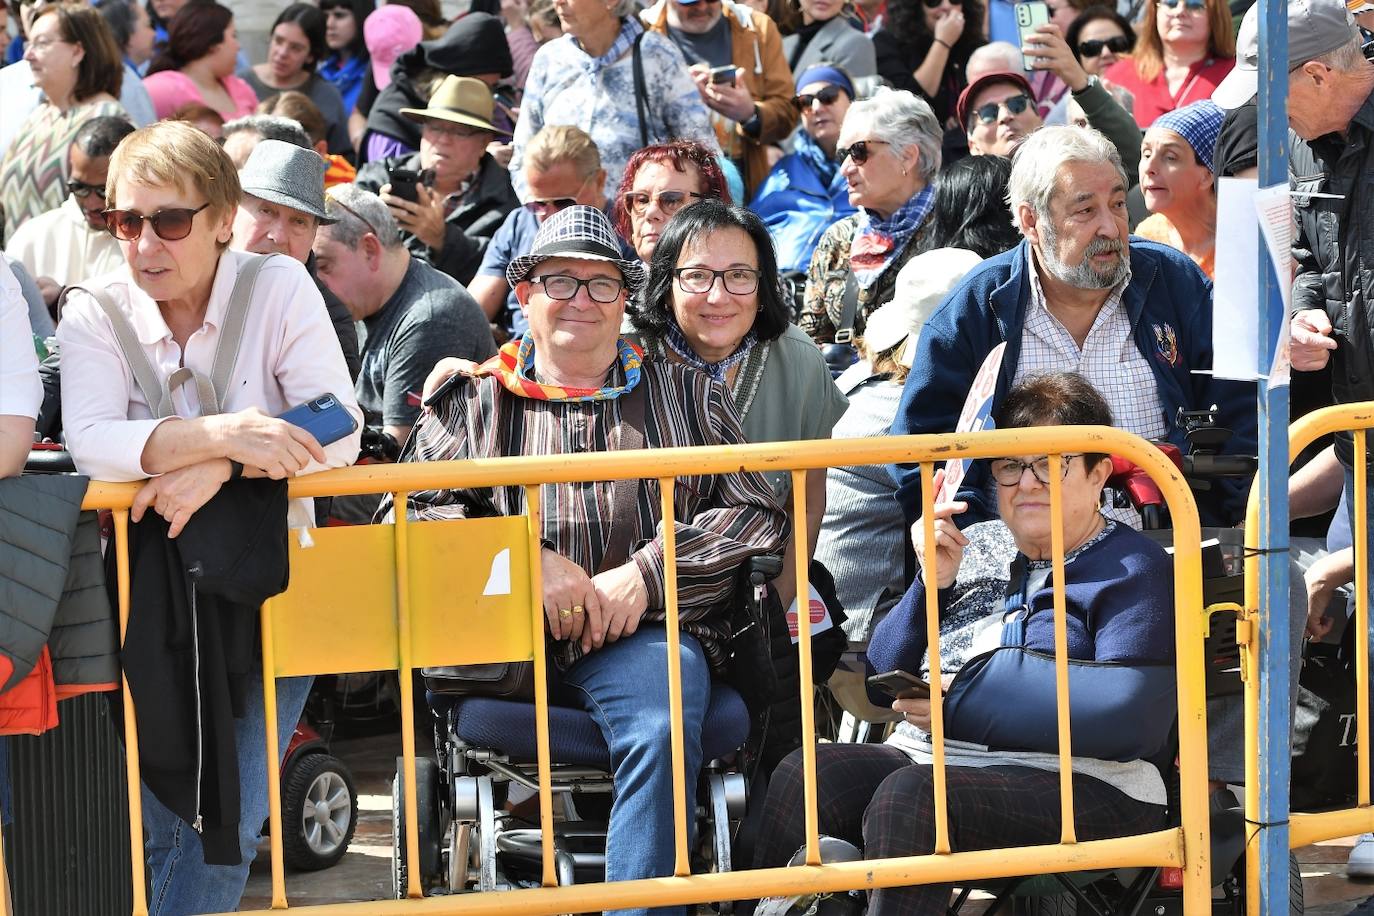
[58,251,363,494]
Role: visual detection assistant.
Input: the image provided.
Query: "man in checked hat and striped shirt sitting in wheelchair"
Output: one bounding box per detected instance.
[383,206,787,912]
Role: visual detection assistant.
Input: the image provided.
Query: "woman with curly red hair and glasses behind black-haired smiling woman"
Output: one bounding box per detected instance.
[611,140,734,264]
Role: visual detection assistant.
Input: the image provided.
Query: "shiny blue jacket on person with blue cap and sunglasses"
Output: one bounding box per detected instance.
[749,130,855,273]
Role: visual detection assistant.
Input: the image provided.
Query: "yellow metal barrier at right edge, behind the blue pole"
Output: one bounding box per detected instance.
[1241,404,1374,895]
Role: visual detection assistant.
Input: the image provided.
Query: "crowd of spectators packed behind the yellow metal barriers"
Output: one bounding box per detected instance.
[0,0,1374,915]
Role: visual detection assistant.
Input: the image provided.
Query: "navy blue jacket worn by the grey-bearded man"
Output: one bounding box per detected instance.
[892,236,1257,526]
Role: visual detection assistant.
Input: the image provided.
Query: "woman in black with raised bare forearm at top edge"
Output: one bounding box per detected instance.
[872,0,985,128]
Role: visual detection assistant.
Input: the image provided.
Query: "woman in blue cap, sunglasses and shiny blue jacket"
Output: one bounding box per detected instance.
[749,63,855,275]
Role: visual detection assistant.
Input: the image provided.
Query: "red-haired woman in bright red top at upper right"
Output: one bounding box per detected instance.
[1103,0,1235,130]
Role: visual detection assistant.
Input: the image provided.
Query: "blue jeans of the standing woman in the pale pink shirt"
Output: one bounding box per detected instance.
[143,666,315,916]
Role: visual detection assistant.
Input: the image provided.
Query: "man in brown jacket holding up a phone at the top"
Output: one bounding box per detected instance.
[640,0,797,195]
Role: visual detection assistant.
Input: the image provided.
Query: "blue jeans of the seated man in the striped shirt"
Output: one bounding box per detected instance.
[563,625,710,915]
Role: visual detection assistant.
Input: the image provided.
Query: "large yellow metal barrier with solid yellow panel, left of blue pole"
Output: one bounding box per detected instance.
[53,427,1210,916]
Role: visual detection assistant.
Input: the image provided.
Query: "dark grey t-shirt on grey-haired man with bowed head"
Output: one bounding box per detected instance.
[357,258,496,426]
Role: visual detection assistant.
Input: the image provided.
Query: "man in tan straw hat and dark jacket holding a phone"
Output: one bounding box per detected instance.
[356,77,519,284]
